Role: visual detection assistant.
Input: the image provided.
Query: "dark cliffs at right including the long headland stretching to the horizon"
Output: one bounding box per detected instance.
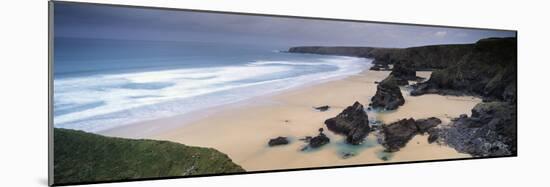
[289,38,517,102]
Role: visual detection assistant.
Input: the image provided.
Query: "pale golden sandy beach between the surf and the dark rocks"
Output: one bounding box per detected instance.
[101,71,481,171]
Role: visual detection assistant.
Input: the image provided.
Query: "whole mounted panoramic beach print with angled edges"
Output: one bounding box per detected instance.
[48,1,517,185]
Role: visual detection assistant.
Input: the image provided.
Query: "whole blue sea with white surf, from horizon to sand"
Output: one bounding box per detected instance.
[53,38,371,132]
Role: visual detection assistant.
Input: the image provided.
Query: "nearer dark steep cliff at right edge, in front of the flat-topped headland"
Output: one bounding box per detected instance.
[411,38,517,103]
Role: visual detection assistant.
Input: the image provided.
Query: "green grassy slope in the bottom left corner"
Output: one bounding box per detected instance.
[54,128,244,184]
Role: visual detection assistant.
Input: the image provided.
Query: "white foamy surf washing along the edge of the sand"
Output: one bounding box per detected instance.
[54,56,370,132]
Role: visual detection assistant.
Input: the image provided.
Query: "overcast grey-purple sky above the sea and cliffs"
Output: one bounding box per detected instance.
[54,2,515,47]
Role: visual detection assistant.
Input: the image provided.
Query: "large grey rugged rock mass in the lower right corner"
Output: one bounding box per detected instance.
[429,102,517,157]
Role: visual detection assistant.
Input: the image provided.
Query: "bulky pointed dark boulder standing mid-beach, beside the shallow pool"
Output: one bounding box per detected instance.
[325,101,370,145]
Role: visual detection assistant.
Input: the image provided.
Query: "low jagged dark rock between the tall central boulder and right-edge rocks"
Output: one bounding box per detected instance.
[379,117,441,152]
